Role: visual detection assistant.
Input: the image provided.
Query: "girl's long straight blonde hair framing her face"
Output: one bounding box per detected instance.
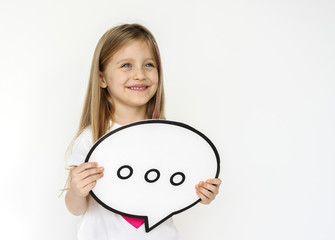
[76,24,165,142]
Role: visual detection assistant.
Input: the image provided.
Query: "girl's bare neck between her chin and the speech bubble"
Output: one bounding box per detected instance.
[114,107,148,125]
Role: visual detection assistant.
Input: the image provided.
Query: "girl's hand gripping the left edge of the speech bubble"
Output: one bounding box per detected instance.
[70,162,104,197]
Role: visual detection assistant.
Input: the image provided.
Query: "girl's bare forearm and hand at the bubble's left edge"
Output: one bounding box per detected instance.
[65,162,103,216]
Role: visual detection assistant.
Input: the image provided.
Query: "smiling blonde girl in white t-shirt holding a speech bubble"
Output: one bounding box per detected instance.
[65,24,221,240]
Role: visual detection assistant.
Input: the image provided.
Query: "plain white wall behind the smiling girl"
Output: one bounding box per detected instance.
[0,0,335,240]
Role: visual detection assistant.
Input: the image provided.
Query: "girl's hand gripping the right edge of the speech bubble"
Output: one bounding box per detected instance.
[195,178,222,204]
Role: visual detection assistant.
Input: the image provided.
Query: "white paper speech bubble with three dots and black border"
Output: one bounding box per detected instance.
[85,120,220,232]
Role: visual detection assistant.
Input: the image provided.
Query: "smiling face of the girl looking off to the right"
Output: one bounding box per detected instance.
[100,40,158,111]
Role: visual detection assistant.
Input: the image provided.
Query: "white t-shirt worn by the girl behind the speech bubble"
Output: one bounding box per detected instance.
[67,124,179,240]
